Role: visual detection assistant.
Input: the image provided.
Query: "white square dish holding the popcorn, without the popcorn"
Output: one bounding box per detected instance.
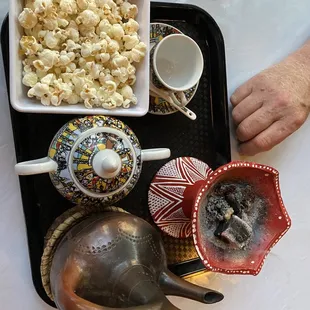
[9,0,151,117]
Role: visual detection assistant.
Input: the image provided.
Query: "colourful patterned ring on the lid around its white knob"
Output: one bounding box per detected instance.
[72,132,135,193]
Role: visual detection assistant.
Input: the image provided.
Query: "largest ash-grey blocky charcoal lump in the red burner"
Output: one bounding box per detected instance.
[215,215,253,249]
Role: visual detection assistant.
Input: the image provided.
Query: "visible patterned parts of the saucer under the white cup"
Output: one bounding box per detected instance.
[149,23,199,115]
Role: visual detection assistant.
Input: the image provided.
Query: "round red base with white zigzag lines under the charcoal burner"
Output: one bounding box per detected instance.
[148,157,212,238]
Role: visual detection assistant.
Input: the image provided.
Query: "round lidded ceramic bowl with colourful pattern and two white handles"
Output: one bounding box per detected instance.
[15,116,170,205]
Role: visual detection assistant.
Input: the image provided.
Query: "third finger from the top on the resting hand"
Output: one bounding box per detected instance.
[236,108,275,142]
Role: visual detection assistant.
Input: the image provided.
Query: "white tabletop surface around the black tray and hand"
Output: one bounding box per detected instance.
[0,0,310,310]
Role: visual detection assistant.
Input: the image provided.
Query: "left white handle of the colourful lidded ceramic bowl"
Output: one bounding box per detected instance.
[15,157,58,175]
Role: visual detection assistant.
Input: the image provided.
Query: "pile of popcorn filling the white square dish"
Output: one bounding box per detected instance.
[18,0,146,109]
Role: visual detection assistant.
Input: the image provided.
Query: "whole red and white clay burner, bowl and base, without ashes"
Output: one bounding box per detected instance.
[149,157,291,275]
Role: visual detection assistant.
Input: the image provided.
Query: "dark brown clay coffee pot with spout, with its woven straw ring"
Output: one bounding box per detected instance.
[41,206,223,310]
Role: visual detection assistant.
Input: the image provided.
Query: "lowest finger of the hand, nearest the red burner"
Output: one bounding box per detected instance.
[239,119,292,156]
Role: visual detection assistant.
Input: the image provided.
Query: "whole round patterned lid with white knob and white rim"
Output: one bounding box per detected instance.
[69,127,137,198]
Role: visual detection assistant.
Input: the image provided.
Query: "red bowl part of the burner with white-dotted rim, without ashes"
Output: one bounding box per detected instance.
[192,161,291,276]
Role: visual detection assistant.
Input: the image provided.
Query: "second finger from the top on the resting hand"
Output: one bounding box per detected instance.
[232,94,264,125]
